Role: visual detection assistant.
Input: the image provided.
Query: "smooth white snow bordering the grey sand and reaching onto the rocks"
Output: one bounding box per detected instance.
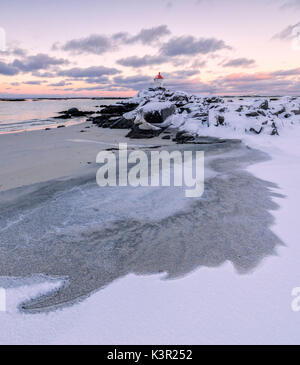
[0,87,300,345]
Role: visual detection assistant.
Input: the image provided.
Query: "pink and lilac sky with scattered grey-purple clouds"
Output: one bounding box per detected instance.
[0,0,300,97]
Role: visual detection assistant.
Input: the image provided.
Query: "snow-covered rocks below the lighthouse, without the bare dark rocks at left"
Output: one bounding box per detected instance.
[91,88,300,138]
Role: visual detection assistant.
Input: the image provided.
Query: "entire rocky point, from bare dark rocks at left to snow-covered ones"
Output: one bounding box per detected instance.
[55,87,300,143]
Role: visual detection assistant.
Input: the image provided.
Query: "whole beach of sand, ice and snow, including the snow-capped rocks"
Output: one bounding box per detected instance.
[0,90,300,344]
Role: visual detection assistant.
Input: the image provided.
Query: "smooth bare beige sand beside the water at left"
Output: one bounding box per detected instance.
[0,122,172,191]
